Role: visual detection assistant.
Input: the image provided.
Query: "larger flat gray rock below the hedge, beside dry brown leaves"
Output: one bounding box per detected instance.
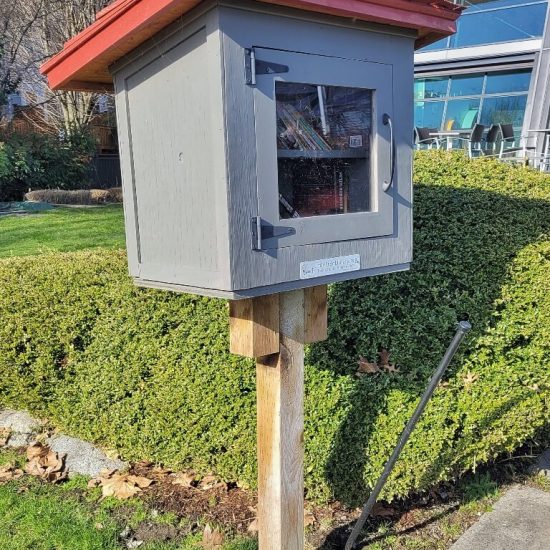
[47,435,127,477]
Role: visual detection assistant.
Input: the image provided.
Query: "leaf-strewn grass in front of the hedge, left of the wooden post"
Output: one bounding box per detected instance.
[0,449,257,550]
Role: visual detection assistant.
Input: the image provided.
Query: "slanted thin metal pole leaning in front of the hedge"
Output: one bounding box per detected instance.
[344,321,472,550]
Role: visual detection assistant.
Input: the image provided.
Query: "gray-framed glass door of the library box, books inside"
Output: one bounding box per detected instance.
[254,48,393,249]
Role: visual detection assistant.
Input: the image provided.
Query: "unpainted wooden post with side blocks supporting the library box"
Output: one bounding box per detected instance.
[231,287,327,550]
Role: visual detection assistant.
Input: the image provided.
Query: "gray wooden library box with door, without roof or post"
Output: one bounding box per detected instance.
[111,2,415,299]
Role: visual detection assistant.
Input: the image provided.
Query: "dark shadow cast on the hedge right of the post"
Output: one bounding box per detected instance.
[309,185,550,516]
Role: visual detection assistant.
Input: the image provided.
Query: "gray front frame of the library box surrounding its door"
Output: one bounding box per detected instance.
[220,8,414,291]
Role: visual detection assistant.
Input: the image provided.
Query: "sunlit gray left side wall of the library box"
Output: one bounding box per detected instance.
[113,10,229,288]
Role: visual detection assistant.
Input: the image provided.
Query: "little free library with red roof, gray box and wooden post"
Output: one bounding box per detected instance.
[43,0,461,550]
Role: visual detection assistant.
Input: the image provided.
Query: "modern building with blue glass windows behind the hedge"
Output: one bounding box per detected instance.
[414,0,550,152]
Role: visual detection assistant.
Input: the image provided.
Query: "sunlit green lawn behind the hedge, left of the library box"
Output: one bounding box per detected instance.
[0,205,124,258]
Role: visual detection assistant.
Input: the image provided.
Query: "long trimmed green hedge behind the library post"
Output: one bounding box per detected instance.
[0,153,550,504]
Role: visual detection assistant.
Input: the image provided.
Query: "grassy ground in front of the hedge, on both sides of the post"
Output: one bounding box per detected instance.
[0,448,550,550]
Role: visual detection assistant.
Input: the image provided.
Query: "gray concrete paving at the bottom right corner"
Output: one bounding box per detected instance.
[451,486,550,550]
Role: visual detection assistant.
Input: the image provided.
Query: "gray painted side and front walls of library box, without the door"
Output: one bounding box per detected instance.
[112,2,414,298]
